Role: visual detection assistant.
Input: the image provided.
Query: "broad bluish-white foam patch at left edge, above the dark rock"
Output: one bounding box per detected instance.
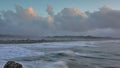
[0,46,43,59]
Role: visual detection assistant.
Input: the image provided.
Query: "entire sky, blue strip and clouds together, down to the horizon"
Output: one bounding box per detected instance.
[0,0,120,37]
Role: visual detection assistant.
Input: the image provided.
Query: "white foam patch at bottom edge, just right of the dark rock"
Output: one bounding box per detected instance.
[22,61,68,68]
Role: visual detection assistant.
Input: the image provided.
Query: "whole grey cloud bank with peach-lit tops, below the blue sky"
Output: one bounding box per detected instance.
[0,6,120,37]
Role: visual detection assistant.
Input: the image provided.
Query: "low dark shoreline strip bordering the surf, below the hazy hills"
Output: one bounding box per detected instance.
[0,38,120,44]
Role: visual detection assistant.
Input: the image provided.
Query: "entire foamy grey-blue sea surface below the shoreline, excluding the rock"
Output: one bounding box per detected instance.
[0,40,120,68]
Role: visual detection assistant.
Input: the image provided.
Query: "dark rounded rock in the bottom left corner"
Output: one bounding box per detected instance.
[4,61,23,68]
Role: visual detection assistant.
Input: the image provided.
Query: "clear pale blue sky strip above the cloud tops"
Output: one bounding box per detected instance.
[0,0,120,15]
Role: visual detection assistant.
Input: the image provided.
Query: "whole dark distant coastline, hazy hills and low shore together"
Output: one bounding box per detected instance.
[0,35,120,44]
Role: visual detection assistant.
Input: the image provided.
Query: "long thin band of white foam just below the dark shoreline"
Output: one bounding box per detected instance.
[19,41,95,48]
